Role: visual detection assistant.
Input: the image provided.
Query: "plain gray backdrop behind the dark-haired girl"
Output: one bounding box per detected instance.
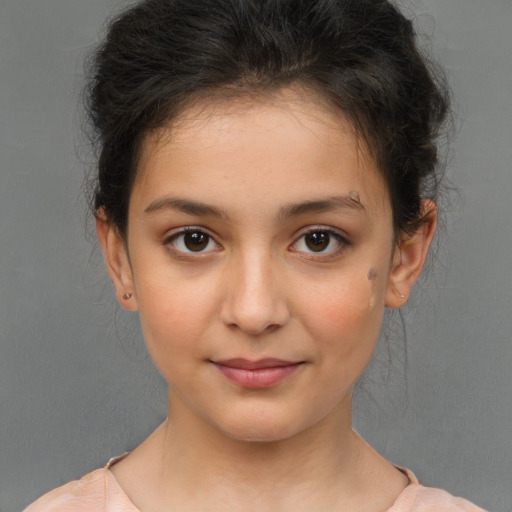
[0,0,512,512]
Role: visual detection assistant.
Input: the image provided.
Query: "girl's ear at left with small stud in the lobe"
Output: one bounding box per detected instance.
[96,208,137,311]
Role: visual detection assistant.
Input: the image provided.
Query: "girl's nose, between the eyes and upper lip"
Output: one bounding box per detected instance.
[221,250,290,336]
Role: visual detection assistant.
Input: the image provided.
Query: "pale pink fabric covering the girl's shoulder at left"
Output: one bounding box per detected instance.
[23,468,138,512]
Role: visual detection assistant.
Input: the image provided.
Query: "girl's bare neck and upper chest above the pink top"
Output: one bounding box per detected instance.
[112,390,407,512]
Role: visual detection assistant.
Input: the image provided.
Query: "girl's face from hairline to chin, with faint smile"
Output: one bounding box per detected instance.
[100,91,432,441]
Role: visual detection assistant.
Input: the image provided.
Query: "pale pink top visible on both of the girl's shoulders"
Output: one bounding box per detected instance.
[24,459,485,512]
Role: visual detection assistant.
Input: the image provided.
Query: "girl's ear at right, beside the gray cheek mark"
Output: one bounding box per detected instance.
[386,200,437,308]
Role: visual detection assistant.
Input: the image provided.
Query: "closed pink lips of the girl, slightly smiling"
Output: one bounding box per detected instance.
[213,358,302,389]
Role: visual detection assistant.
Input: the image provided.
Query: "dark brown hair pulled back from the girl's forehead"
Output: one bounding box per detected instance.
[88,0,448,234]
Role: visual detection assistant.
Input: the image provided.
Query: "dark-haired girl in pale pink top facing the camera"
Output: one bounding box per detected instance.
[26,0,481,512]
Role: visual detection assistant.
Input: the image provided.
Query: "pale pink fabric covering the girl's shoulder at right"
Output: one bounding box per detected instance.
[388,484,485,512]
